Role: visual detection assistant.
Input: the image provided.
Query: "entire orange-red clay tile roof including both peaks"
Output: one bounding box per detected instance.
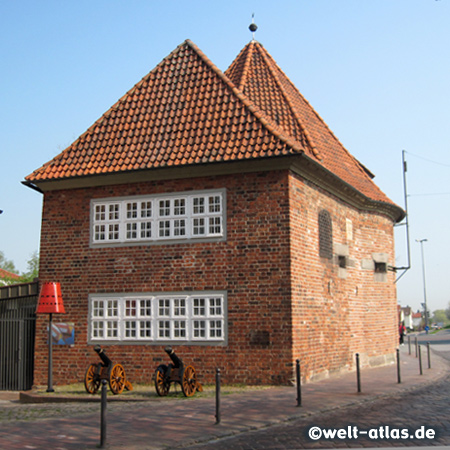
[26,40,400,216]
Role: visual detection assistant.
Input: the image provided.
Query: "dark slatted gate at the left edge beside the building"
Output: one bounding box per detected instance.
[0,281,39,391]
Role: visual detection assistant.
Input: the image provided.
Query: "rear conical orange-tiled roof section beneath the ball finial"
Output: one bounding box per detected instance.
[225,41,391,203]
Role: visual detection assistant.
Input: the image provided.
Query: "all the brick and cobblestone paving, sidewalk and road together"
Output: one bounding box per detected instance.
[0,346,450,450]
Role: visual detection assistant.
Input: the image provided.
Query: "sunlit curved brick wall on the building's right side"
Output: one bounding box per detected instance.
[290,171,398,379]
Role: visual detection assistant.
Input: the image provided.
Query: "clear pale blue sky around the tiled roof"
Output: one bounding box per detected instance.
[0,0,450,311]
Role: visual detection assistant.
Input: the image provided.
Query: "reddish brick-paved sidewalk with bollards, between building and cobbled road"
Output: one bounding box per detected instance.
[0,345,450,450]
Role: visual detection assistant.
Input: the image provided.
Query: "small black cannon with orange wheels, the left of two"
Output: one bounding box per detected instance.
[84,345,133,394]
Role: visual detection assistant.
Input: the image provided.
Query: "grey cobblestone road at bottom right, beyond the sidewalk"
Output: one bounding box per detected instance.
[185,377,450,450]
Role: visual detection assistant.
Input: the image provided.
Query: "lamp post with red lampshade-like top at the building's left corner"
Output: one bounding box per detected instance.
[36,282,66,392]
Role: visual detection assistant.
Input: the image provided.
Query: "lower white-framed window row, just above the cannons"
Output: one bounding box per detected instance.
[89,292,227,344]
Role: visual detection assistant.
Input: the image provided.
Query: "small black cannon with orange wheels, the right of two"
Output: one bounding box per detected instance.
[155,347,203,397]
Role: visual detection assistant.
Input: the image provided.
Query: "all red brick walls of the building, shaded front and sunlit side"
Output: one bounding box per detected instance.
[34,171,397,385]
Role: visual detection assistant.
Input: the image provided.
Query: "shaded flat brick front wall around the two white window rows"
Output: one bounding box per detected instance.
[34,171,292,385]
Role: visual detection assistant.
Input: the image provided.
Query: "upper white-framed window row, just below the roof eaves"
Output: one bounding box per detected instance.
[91,189,226,245]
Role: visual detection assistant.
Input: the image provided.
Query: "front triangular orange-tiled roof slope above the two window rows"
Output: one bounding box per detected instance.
[26,40,302,182]
